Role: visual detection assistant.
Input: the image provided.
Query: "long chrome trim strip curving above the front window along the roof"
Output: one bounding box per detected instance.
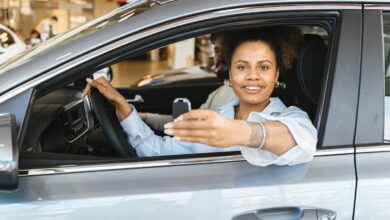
[0,3,361,103]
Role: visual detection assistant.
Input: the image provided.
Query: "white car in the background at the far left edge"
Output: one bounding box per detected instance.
[0,24,27,63]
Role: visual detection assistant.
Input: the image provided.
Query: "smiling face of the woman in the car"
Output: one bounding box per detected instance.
[230,41,279,105]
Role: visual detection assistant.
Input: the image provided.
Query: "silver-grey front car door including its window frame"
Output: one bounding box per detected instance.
[0,3,362,219]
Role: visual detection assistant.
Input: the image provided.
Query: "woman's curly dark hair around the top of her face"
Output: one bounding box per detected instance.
[226,26,303,73]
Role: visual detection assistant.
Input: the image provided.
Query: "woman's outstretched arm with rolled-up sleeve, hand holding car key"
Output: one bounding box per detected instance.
[165,109,317,166]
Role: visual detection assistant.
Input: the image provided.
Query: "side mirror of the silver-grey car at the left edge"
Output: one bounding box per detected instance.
[0,114,19,190]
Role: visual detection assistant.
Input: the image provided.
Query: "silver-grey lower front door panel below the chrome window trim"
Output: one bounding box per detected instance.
[0,153,355,220]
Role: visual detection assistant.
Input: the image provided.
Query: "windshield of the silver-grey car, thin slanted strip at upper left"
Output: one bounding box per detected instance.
[0,0,162,75]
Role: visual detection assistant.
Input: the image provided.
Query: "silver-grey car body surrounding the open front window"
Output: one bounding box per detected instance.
[0,0,390,220]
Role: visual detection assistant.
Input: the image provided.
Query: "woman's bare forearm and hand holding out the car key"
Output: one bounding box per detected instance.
[165,110,295,154]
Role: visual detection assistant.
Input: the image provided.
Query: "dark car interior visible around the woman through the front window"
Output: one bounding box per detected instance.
[19,25,329,169]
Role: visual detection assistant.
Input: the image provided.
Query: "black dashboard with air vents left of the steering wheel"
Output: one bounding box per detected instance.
[22,87,94,153]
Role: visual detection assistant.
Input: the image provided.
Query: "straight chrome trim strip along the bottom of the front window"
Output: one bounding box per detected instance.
[19,148,354,177]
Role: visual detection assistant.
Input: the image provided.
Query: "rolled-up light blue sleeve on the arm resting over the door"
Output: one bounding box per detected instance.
[241,106,317,166]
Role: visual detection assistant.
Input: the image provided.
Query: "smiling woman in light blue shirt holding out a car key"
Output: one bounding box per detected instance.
[84,28,317,166]
